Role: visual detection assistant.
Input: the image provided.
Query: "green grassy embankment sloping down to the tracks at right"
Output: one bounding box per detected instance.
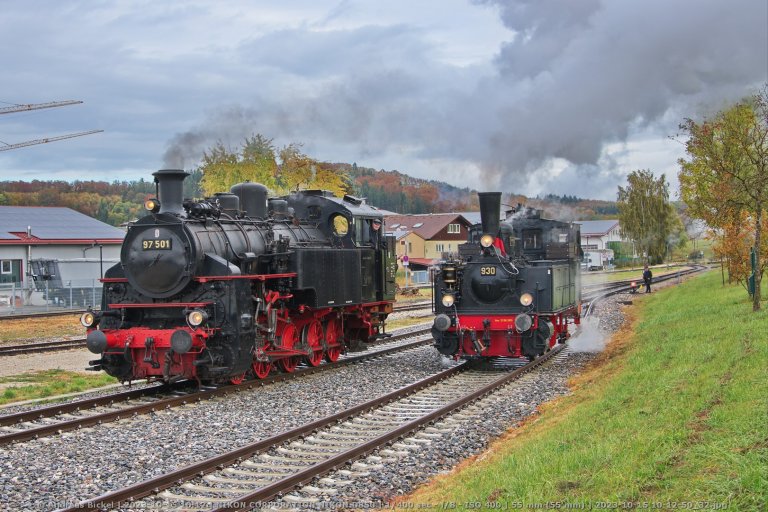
[406,272,768,511]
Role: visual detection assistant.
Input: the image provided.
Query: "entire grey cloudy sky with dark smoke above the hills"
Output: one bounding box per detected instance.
[0,0,768,200]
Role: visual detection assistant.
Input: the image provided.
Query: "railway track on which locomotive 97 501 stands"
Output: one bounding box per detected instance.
[0,329,432,446]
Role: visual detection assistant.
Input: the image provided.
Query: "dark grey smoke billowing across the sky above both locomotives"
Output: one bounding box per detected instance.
[160,0,768,197]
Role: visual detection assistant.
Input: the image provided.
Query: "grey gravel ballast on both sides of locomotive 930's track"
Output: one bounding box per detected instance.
[0,296,627,511]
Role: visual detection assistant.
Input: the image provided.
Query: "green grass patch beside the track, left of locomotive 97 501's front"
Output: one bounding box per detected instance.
[0,370,117,405]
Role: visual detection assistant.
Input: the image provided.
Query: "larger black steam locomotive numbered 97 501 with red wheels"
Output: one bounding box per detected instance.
[81,170,397,383]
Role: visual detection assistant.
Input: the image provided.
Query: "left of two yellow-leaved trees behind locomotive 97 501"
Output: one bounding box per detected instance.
[199,134,277,195]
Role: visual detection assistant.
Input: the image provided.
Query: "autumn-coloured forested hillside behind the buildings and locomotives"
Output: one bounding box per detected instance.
[0,166,616,226]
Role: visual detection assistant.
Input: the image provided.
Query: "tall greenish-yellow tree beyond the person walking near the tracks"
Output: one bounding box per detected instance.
[616,169,679,262]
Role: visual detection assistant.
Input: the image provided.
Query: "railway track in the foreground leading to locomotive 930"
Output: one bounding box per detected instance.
[64,345,564,511]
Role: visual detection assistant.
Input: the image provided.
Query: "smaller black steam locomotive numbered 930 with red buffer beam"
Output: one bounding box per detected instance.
[432,192,581,359]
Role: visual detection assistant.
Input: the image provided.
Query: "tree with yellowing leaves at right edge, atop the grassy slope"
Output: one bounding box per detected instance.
[679,85,768,311]
